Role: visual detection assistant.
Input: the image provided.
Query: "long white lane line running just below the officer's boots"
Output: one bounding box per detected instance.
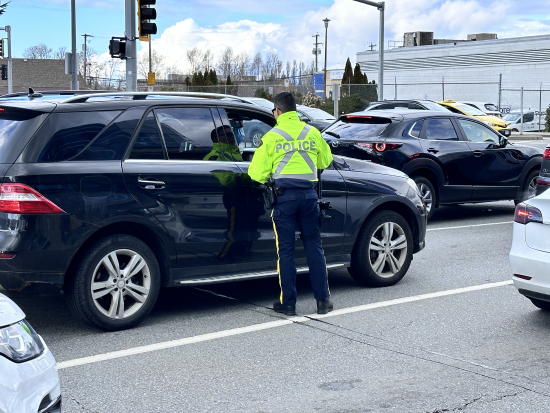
[57,280,512,370]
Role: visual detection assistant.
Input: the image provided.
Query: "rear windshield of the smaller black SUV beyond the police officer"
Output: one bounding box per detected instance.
[323,115,391,139]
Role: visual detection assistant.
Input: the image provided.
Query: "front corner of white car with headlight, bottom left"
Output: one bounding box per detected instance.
[0,293,61,413]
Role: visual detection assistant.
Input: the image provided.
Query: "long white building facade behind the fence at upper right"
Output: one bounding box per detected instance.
[357,35,550,110]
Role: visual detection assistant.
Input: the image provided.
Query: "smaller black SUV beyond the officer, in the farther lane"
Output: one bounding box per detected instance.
[323,110,542,216]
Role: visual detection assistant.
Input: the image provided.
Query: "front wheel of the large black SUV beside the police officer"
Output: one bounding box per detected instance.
[348,211,413,287]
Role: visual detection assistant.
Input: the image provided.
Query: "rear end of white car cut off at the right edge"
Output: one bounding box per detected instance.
[510,191,550,311]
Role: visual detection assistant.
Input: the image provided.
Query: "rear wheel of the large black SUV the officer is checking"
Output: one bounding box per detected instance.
[65,234,160,331]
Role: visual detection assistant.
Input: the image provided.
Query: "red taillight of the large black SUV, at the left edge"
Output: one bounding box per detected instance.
[0,184,66,214]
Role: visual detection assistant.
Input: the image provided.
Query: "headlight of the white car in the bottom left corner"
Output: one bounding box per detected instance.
[0,320,44,363]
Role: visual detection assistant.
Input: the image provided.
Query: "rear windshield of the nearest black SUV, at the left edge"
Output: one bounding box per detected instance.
[0,108,48,163]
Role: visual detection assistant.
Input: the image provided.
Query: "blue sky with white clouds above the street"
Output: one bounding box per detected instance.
[0,0,550,71]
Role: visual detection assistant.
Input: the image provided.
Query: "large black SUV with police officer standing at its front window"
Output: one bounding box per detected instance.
[0,93,426,330]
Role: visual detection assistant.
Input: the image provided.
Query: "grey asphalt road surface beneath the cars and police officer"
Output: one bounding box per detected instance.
[7,141,550,413]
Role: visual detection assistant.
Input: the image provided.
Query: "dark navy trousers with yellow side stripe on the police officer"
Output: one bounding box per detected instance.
[271,188,330,305]
